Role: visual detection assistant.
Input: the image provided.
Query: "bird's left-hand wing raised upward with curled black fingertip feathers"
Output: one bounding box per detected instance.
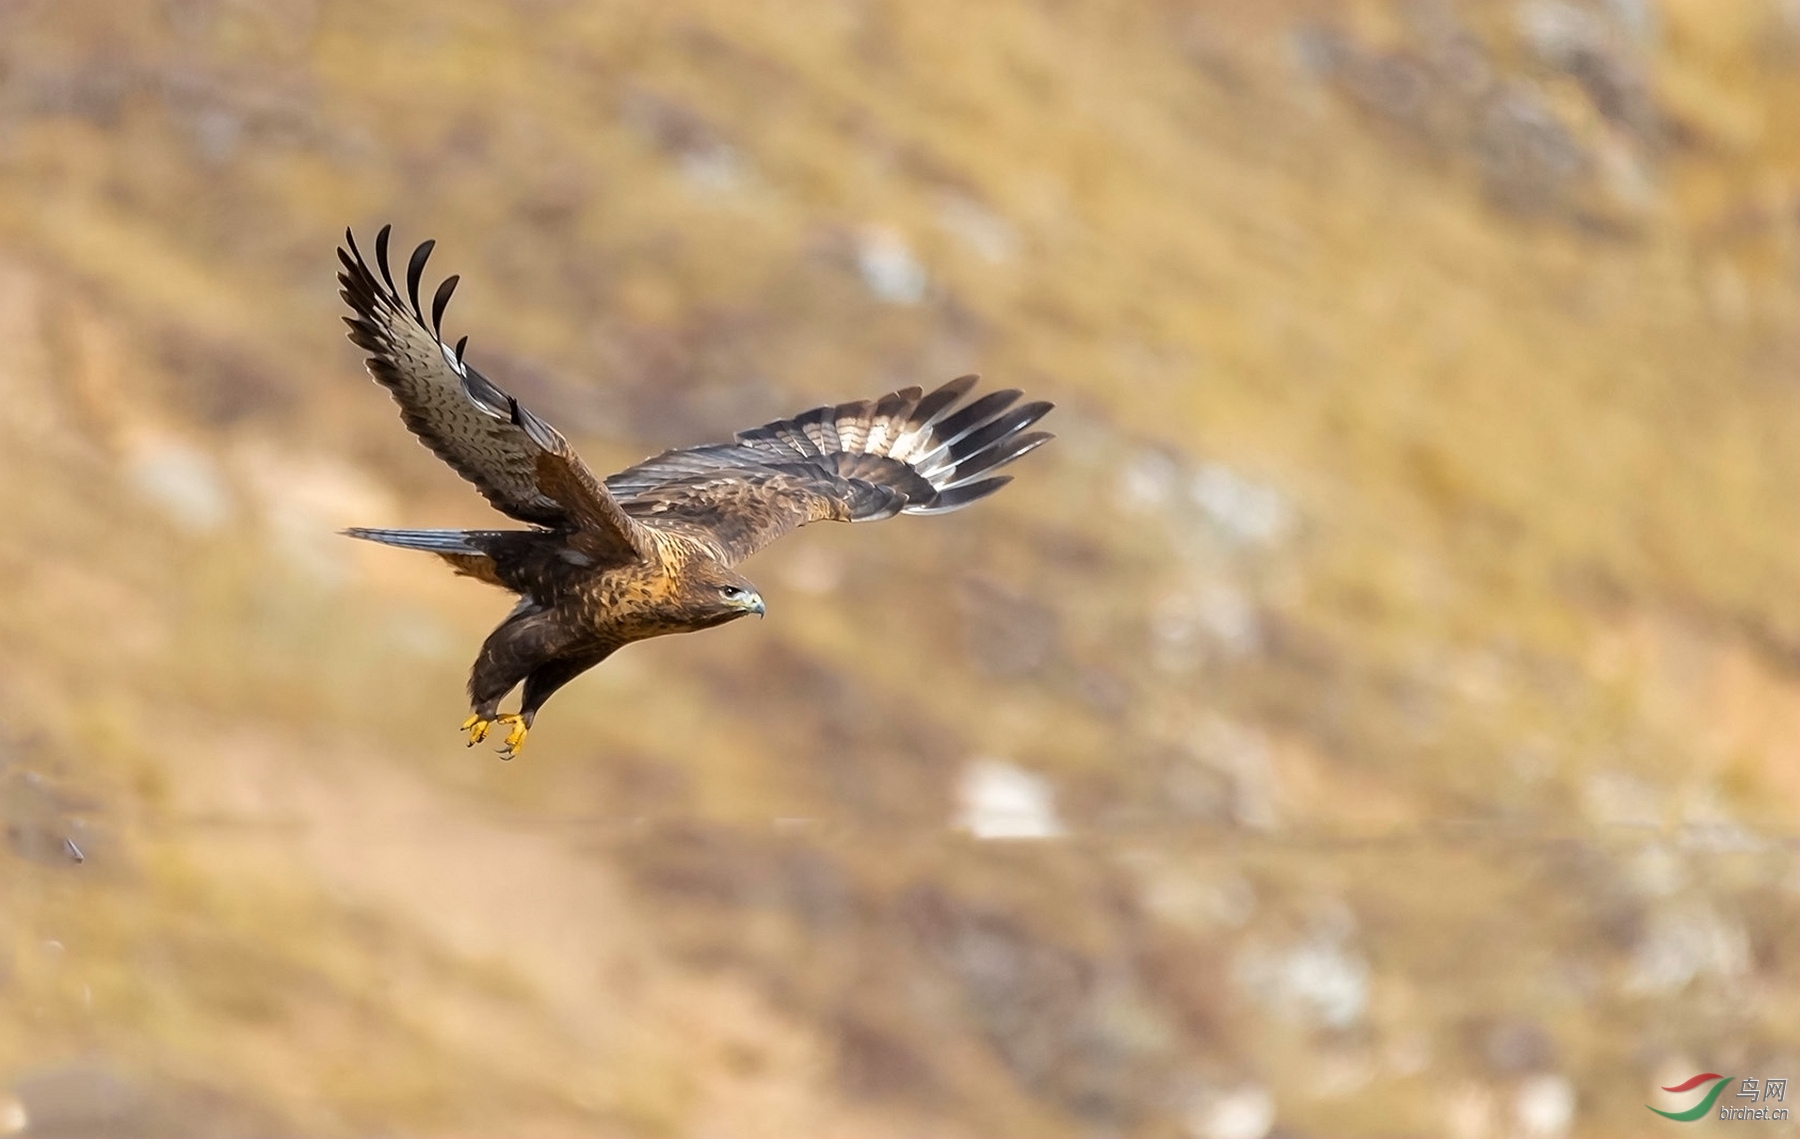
[338,225,644,558]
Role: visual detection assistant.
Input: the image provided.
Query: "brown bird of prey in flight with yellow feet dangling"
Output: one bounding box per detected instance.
[338,227,1051,759]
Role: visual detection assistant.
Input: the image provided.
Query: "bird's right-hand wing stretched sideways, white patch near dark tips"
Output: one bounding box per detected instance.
[607,376,1051,563]
